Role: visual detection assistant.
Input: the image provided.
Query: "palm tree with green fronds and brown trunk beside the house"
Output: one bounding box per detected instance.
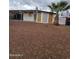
[48,1,68,25]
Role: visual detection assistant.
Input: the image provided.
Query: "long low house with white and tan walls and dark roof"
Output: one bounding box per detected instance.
[9,10,56,24]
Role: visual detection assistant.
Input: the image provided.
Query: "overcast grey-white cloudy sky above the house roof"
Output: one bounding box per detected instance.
[9,0,69,11]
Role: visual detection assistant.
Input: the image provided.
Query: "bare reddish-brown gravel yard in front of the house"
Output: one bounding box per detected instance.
[9,21,70,59]
